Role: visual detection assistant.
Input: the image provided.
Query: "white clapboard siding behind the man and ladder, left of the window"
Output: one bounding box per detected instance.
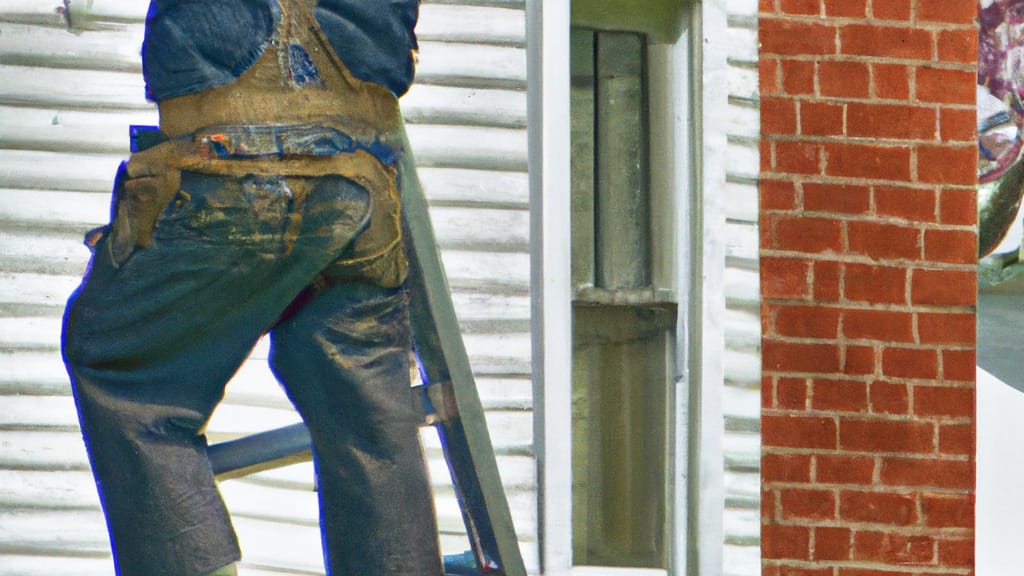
[0,0,539,576]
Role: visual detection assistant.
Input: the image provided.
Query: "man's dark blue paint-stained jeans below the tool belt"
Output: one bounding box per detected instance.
[63,151,440,576]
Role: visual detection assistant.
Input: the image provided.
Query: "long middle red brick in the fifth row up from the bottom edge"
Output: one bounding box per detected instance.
[839,417,935,454]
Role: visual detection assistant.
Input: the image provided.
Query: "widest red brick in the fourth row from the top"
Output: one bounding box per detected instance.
[846,102,938,140]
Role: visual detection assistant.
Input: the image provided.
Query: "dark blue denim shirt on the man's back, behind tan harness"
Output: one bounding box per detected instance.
[142,0,419,101]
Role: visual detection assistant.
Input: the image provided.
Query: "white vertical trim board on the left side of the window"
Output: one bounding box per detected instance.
[526,0,572,576]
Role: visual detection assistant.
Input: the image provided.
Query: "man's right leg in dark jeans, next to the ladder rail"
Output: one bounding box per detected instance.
[271,283,441,576]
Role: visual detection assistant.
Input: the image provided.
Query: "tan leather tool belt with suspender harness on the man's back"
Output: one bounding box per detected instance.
[92,0,408,286]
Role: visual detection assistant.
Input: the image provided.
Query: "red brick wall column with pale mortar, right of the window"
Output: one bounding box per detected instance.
[760,0,977,576]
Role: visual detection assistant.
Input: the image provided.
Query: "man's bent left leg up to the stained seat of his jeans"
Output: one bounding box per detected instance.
[63,168,366,576]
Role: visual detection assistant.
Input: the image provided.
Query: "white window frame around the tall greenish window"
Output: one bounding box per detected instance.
[526,0,728,576]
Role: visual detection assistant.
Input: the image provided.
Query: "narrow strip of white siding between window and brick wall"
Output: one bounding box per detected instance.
[723,0,761,576]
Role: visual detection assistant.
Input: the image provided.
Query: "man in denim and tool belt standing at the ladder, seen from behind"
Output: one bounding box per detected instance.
[63,0,441,576]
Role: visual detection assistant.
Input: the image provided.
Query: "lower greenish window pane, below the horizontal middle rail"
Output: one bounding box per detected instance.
[572,304,676,568]
